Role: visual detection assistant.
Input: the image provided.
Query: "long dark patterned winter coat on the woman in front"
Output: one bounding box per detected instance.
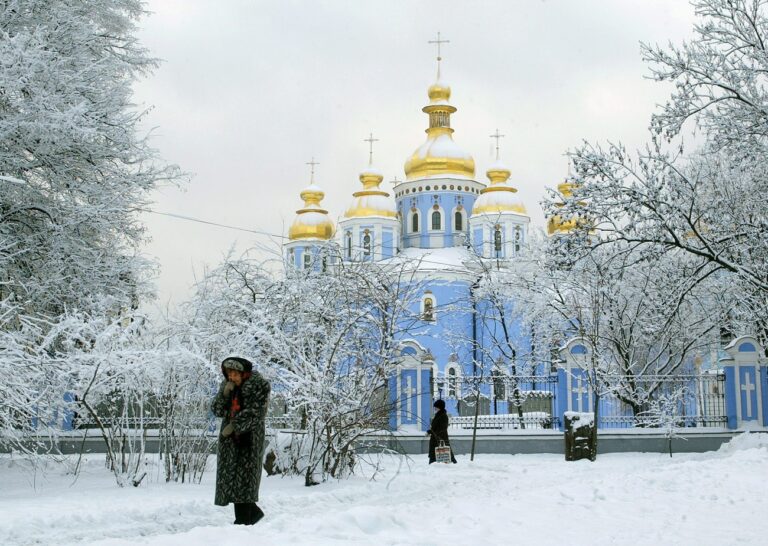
[211,370,269,506]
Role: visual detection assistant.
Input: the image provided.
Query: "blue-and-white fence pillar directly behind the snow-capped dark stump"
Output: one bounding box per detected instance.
[557,337,598,430]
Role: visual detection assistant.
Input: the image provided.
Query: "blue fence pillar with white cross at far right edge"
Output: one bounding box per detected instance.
[720,336,768,429]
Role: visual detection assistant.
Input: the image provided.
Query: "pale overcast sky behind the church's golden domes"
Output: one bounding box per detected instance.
[130,0,694,306]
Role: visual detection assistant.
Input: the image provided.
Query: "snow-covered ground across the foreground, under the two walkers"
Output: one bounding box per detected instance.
[0,434,768,546]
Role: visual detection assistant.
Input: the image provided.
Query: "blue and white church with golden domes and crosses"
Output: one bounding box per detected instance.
[285,46,561,428]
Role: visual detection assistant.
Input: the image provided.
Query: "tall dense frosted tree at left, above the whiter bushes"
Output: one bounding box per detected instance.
[0,0,177,316]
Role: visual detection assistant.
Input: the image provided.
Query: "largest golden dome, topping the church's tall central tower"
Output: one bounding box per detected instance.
[405,78,475,180]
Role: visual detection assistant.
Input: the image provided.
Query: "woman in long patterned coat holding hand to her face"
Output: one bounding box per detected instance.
[211,357,269,525]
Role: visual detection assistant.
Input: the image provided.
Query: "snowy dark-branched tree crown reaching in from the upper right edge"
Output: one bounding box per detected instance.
[546,0,768,348]
